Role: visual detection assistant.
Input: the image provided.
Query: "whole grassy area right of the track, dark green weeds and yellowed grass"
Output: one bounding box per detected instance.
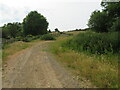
[51,32,119,88]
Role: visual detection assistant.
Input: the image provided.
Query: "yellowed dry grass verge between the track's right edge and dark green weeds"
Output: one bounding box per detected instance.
[50,34,118,88]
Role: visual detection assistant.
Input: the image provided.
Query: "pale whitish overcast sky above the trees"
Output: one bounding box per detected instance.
[0,0,102,31]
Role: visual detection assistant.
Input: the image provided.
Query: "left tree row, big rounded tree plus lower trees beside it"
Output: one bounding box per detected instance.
[2,11,49,39]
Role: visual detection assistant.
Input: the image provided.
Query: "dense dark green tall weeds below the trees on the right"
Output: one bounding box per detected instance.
[62,32,120,54]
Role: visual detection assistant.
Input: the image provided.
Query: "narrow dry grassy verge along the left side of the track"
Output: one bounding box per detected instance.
[2,40,39,63]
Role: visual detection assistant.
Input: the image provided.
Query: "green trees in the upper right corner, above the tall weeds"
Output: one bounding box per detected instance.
[88,2,120,32]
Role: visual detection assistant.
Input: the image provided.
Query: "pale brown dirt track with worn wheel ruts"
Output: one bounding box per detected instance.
[2,41,83,88]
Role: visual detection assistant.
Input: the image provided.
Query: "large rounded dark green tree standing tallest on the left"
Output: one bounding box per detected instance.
[23,11,48,36]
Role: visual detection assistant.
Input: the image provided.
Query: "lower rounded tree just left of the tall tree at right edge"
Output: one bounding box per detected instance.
[88,11,108,32]
